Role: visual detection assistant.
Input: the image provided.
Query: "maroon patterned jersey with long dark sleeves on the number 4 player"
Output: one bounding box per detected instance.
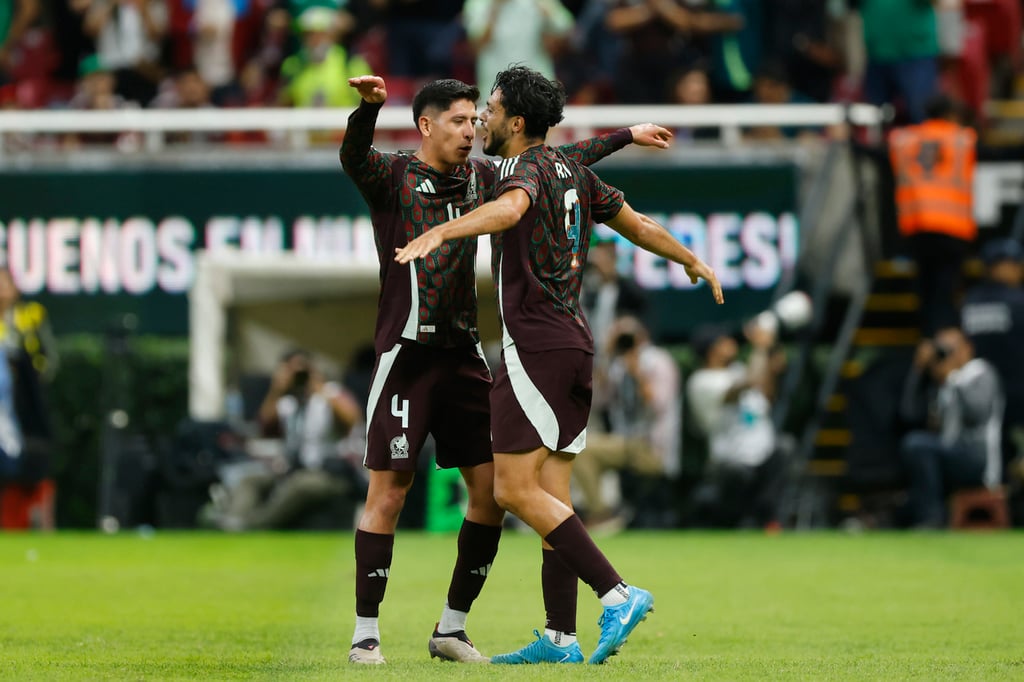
[341,102,633,353]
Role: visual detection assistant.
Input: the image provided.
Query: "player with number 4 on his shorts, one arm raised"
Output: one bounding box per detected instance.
[341,76,684,664]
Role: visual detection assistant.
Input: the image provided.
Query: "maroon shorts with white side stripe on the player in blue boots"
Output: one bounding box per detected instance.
[490,345,594,455]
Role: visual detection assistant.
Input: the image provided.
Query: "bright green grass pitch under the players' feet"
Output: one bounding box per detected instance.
[0,531,1024,680]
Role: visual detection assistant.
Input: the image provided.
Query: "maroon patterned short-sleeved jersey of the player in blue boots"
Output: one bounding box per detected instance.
[492,144,625,352]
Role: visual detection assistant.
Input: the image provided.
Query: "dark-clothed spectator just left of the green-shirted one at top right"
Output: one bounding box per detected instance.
[765,0,846,102]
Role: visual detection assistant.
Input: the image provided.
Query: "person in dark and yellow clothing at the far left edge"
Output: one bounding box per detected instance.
[0,268,57,528]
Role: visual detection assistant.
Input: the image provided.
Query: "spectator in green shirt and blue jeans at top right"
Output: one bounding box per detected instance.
[850,0,939,123]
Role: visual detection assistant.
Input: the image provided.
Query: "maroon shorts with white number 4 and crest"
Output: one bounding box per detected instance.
[364,341,494,471]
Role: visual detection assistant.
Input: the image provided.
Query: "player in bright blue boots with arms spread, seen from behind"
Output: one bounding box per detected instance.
[395,66,724,664]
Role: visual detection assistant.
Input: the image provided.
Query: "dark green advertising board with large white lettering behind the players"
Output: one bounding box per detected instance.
[0,159,799,339]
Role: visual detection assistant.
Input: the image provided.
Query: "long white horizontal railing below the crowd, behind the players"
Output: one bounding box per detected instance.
[0,104,884,151]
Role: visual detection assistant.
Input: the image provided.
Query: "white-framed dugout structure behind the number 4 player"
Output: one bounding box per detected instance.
[188,248,498,420]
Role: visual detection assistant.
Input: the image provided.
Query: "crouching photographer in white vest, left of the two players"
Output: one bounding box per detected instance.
[211,350,362,530]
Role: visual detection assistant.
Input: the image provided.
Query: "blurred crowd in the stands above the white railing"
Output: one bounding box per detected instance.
[0,0,1022,137]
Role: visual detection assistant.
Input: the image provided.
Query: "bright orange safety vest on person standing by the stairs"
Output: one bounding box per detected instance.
[889,120,978,242]
